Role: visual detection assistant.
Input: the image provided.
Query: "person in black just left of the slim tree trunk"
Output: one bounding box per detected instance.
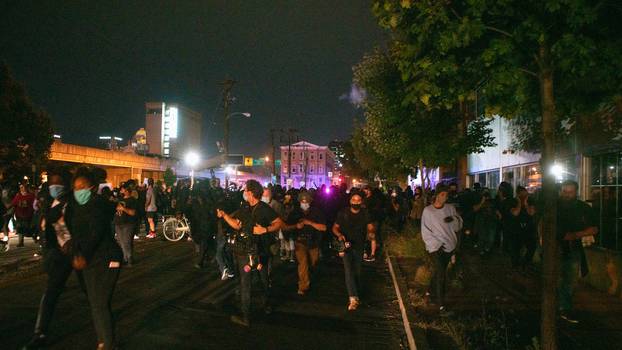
[510,186,538,271]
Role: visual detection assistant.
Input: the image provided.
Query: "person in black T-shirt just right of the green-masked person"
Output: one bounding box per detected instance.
[113,183,138,267]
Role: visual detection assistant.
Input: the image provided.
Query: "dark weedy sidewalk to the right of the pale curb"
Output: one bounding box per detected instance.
[396,249,622,350]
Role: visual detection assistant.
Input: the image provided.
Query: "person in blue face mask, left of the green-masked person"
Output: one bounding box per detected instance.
[24,168,73,349]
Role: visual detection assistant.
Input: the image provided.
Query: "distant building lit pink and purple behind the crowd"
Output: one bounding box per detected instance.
[281,141,335,188]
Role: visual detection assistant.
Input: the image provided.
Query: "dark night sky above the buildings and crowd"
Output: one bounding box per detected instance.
[0,0,384,156]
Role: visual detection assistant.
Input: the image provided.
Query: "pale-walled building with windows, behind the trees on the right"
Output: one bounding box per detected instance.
[466,117,622,296]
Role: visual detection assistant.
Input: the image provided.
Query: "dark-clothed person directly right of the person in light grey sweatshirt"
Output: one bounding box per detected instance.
[473,191,498,256]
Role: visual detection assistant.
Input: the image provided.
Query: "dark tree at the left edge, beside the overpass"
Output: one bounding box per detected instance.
[0,63,53,183]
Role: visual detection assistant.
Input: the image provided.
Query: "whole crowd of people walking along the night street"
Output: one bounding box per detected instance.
[1,167,597,349]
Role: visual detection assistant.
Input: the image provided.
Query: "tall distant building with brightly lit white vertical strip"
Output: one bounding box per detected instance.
[145,102,202,159]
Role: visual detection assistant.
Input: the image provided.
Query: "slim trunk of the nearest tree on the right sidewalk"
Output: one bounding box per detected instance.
[538,43,558,350]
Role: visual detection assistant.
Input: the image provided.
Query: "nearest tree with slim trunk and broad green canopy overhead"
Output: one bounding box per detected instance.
[373,0,622,349]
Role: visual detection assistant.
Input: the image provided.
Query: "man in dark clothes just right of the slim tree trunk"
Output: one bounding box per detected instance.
[557,180,598,324]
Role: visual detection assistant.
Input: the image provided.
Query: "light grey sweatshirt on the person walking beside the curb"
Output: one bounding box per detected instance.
[421,203,462,253]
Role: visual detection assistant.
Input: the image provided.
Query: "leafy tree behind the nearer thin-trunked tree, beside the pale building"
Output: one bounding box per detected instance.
[354,48,494,186]
